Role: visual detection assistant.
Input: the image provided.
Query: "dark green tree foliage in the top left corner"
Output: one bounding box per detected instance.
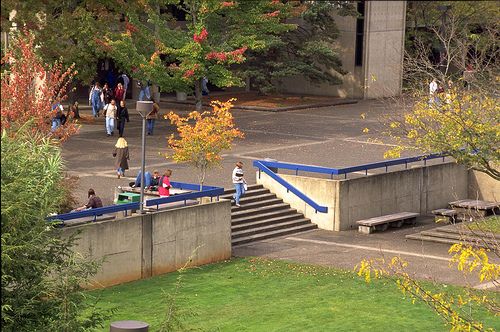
[1,0,133,83]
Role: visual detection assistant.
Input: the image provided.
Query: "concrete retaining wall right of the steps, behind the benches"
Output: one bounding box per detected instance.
[257,163,468,231]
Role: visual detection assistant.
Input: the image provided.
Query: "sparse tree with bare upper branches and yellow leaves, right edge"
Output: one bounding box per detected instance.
[380,1,500,180]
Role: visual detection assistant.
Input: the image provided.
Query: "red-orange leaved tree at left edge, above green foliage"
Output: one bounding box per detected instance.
[0,31,78,139]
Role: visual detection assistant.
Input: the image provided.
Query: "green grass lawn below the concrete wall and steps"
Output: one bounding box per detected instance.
[91,258,500,332]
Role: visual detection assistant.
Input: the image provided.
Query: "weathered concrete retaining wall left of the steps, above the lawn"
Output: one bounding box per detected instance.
[62,201,231,287]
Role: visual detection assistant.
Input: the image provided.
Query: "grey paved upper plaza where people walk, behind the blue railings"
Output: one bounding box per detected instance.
[63,101,410,204]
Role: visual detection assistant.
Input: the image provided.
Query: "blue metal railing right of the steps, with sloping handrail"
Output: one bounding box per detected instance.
[253,153,447,213]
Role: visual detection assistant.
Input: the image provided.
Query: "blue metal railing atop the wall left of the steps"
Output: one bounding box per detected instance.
[47,182,224,222]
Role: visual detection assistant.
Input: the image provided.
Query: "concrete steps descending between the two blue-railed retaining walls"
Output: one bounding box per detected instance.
[221,185,318,246]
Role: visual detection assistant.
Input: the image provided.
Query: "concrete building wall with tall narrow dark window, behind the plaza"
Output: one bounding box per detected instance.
[282,1,406,99]
